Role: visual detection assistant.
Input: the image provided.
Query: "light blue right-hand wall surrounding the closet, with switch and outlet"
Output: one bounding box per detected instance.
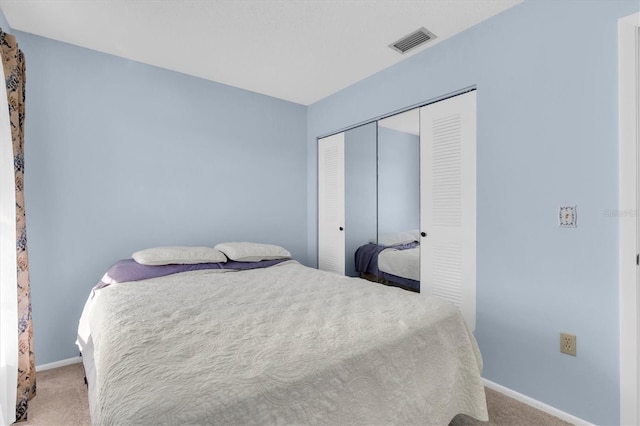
[307,0,639,424]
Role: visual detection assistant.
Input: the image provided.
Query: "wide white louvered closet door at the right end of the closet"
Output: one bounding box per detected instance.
[420,91,476,331]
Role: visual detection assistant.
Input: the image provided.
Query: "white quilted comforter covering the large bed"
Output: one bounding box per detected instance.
[78,261,488,425]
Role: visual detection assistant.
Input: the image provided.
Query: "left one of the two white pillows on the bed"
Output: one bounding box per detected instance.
[131,246,227,265]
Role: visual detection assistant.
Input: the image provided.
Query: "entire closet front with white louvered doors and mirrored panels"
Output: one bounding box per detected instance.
[318,90,476,330]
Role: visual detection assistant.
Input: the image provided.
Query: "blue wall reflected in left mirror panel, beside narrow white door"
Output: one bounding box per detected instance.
[344,123,377,277]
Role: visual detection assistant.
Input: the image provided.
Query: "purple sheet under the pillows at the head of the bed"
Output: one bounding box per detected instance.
[94,258,290,290]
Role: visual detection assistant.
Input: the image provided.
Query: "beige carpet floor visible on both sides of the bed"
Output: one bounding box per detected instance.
[26,364,569,426]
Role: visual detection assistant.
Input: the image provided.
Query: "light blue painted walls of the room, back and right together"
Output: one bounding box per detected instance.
[8,0,639,424]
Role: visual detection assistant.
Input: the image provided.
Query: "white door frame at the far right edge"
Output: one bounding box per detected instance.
[613,13,640,425]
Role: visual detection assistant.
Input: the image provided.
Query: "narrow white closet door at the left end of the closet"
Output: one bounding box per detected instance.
[318,133,345,275]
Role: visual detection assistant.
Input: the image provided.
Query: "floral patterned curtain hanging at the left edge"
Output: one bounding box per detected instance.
[0,30,36,421]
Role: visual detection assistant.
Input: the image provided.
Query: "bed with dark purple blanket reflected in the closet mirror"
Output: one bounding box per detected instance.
[354,231,420,292]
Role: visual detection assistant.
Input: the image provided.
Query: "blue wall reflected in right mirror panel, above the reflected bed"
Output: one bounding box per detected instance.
[378,127,420,233]
